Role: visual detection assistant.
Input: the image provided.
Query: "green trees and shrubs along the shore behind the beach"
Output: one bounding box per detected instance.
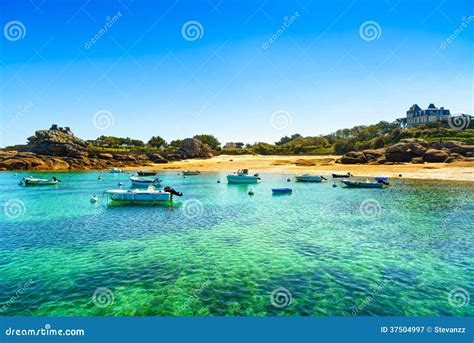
[85,121,474,155]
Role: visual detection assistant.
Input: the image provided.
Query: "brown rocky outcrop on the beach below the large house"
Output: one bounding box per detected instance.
[338,139,474,164]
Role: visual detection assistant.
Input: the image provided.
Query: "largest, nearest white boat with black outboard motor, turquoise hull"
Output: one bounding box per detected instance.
[104,186,183,203]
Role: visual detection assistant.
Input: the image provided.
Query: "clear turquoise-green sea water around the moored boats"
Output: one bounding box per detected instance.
[0,171,474,316]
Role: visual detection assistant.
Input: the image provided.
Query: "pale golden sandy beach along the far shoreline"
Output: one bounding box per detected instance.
[121,155,474,182]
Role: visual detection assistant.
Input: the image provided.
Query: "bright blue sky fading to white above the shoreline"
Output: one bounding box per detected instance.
[0,0,474,146]
